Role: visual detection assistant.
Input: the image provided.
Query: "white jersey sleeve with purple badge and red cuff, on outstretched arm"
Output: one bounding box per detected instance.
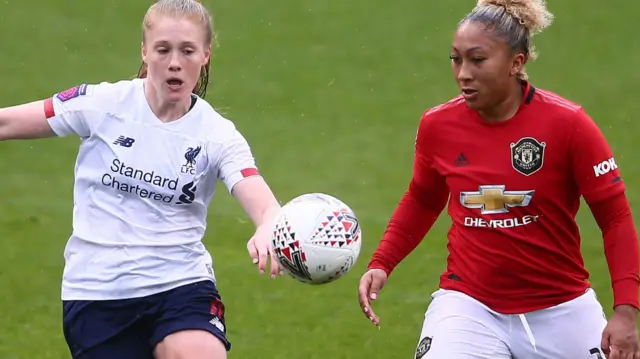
[45,82,117,137]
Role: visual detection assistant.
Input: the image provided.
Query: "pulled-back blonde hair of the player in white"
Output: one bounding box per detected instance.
[136,0,215,98]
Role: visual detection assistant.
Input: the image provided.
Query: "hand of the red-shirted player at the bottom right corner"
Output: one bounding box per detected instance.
[602,305,640,359]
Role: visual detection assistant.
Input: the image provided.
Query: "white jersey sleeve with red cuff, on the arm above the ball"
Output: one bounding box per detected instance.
[218,128,260,192]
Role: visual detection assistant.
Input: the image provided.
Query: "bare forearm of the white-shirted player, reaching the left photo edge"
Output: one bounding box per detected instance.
[0,101,55,141]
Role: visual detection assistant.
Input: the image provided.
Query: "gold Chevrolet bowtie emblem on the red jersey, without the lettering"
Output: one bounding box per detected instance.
[460,185,535,214]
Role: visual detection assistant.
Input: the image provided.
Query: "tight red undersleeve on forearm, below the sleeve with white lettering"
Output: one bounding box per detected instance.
[589,193,640,308]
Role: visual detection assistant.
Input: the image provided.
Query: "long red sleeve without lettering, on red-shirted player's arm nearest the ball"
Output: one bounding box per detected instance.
[368,112,449,275]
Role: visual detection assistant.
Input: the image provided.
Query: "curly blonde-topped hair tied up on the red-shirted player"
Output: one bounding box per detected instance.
[458,0,553,81]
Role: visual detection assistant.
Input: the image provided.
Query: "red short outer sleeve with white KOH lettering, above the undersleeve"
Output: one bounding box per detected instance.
[569,110,625,203]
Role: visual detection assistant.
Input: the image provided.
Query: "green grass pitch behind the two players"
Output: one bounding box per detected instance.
[0,0,640,359]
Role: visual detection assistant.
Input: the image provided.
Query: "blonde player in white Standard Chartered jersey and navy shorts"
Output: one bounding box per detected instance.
[0,0,279,359]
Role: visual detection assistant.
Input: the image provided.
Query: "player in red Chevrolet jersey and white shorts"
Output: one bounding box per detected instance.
[359,0,640,359]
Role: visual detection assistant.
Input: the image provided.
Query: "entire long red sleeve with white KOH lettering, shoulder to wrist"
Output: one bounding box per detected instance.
[569,111,640,308]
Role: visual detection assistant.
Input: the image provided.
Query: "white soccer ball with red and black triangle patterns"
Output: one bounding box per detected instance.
[271,193,362,284]
